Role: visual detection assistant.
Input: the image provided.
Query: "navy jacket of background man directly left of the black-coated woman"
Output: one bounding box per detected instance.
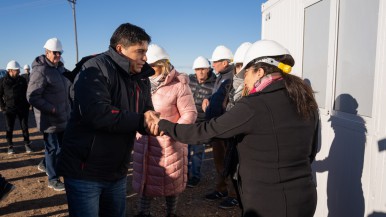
[205,65,235,120]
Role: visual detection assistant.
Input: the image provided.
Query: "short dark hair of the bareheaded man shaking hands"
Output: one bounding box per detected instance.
[110,23,151,49]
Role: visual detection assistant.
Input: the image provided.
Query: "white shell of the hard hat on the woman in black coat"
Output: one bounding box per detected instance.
[237,40,290,78]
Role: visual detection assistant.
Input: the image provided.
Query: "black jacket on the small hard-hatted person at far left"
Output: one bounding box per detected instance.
[0,73,29,112]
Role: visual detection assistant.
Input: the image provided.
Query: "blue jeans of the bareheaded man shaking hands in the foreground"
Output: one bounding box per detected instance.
[64,177,127,217]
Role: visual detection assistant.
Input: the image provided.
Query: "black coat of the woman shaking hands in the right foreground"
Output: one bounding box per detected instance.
[158,81,318,217]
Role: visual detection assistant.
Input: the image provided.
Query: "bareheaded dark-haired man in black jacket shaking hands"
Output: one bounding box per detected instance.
[58,23,154,217]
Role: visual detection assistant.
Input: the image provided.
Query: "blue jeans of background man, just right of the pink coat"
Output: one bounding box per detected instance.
[188,144,205,179]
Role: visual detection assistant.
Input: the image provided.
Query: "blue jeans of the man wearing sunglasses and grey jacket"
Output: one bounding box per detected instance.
[43,132,63,181]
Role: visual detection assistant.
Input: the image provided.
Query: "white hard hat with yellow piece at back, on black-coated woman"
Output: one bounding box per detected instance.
[237,40,292,78]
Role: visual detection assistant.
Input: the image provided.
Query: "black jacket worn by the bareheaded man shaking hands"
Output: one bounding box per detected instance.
[58,48,154,181]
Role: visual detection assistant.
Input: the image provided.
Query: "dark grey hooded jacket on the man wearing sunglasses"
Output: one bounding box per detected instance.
[27,55,71,133]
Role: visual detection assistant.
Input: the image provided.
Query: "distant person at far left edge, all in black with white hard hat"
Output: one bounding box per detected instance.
[0,60,32,154]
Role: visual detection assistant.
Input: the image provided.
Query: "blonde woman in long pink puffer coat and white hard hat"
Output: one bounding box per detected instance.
[132,44,197,216]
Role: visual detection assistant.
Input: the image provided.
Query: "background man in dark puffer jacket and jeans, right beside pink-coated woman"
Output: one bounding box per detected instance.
[187,56,216,188]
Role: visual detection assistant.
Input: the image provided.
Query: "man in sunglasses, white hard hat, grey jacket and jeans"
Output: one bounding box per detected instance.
[27,38,71,191]
